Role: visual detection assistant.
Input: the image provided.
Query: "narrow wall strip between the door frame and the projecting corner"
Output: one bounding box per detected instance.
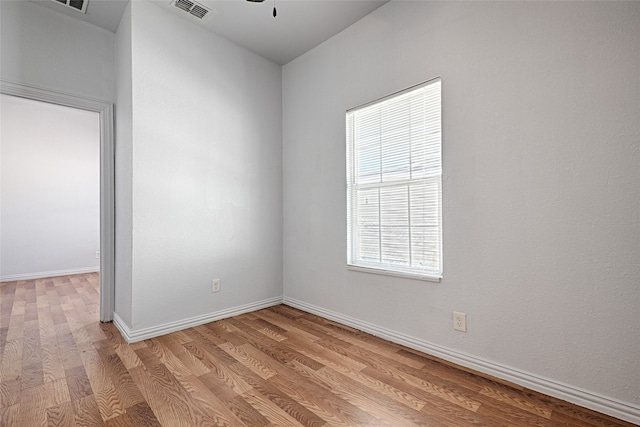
[114,0,133,327]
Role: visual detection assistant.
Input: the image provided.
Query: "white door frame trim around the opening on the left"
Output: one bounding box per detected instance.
[0,80,115,322]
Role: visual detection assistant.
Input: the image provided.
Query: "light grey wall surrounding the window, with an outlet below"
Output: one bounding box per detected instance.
[283,2,640,419]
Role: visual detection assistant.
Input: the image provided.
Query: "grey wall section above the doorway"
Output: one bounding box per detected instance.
[0,1,115,101]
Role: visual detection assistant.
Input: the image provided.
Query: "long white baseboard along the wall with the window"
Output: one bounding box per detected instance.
[283,296,640,425]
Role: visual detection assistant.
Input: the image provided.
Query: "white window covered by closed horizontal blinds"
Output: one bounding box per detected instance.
[346,79,442,280]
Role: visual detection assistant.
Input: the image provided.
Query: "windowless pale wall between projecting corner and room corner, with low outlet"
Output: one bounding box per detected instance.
[126,2,282,333]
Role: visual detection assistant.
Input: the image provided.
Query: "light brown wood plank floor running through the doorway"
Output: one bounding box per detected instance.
[0,274,632,427]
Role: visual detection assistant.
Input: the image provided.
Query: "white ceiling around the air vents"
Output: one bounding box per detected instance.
[30,0,388,65]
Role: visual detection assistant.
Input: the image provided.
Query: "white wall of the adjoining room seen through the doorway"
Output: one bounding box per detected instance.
[0,95,100,280]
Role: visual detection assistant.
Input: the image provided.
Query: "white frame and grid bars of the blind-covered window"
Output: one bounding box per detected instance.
[345,77,444,282]
